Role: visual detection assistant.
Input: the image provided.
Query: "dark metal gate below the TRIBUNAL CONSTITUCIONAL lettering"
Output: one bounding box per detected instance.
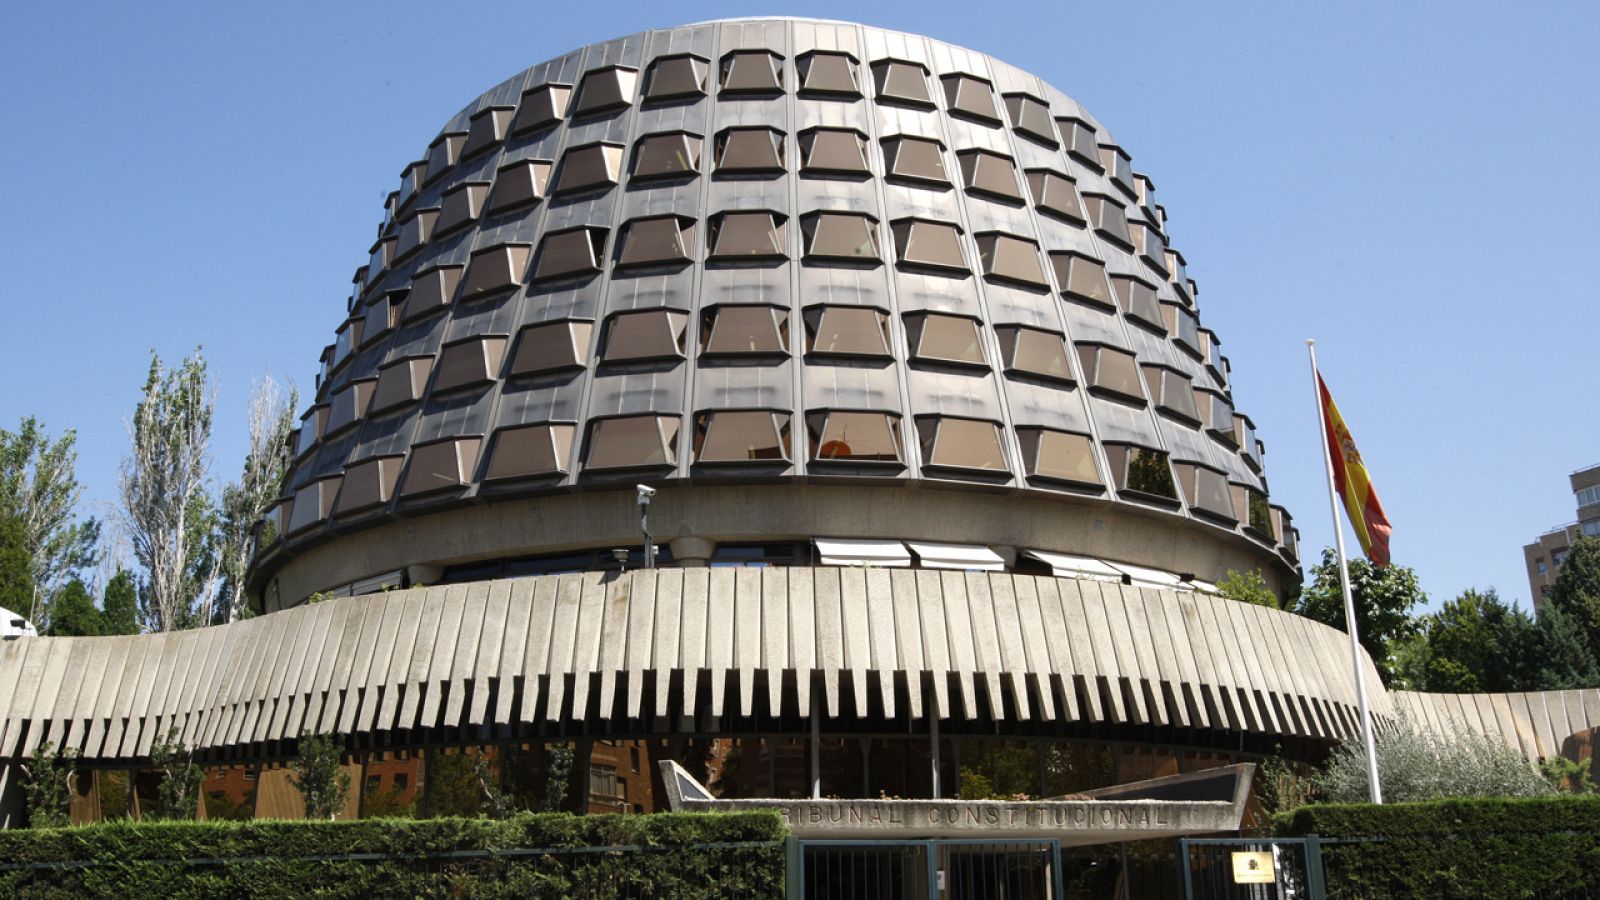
[789,841,1064,900]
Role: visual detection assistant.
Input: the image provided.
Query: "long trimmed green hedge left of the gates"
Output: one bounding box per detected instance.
[0,812,786,898]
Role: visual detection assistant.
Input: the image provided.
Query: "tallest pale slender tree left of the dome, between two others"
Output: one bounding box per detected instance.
[122,349,218,631]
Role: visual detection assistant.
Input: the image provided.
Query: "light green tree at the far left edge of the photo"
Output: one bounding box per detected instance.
[0,416,99,620]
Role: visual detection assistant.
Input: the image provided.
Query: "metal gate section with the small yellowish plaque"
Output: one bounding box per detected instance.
[1178,836,1328,900]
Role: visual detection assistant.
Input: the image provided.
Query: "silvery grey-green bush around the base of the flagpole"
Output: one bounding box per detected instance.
[1312,716,1555,802]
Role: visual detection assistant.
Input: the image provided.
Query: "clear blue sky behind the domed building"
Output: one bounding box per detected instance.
[0,0,1600,604]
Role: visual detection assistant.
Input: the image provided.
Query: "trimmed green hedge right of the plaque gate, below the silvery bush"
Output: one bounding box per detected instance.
[1275,794,1600,898]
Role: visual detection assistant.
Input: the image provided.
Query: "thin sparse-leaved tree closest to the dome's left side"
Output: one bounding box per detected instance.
[218,378,299,621]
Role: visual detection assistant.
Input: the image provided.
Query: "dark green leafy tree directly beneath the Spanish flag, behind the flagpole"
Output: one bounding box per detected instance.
[1293,548,1427,684]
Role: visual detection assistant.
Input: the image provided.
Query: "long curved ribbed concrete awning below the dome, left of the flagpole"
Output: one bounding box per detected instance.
[0,565,1427,761]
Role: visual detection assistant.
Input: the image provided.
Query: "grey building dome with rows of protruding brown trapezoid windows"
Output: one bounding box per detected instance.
[254,19,1296,609]
